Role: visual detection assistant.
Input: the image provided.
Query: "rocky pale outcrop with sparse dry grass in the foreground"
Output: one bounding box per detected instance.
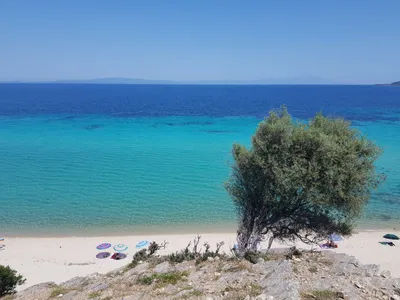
[8,251,400,300]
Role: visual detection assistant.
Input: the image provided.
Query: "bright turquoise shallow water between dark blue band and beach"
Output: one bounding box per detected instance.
[0,116,400,234]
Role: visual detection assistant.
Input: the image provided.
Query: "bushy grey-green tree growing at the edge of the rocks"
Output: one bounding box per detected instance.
[226,107,383,251]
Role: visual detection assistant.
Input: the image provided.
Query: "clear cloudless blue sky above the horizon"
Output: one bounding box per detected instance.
[0,0,400,83]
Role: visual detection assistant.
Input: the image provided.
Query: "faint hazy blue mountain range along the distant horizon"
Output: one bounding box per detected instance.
[47,76,338,85]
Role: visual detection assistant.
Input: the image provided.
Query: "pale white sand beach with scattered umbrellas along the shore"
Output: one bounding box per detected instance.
[0,231,400,289]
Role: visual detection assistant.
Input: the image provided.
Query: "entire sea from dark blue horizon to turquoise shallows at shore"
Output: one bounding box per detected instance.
[0,84,400,236]
